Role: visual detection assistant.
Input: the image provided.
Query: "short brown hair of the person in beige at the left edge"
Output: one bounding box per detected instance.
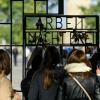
[0,49,11,75]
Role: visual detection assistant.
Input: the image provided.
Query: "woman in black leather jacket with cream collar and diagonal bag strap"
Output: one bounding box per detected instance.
[62,49,100,100]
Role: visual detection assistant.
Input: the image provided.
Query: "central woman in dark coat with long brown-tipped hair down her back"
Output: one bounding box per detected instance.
[28,46,64,100]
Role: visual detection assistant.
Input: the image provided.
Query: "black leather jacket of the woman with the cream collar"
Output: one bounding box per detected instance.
[63,76,100,100]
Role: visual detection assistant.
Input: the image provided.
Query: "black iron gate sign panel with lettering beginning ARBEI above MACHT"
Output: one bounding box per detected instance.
[25,14,99,46]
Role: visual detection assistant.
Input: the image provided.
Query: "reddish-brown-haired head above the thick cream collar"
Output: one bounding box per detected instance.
[68,49,91,67]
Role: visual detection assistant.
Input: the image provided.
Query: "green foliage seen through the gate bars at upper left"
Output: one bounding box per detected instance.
[0,0,57,44]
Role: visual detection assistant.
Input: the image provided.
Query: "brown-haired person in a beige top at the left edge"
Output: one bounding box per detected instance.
[0,49,20,100]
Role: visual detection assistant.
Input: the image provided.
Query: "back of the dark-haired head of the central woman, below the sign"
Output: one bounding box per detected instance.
[43,46,60,69]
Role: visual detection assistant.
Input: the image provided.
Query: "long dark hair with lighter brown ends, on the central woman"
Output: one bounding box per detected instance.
[42,46,60,89]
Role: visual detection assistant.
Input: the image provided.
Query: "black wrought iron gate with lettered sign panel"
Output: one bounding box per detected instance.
[0,0,99,99]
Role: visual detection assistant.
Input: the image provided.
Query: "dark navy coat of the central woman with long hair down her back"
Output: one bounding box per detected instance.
[28,66,64,100]
